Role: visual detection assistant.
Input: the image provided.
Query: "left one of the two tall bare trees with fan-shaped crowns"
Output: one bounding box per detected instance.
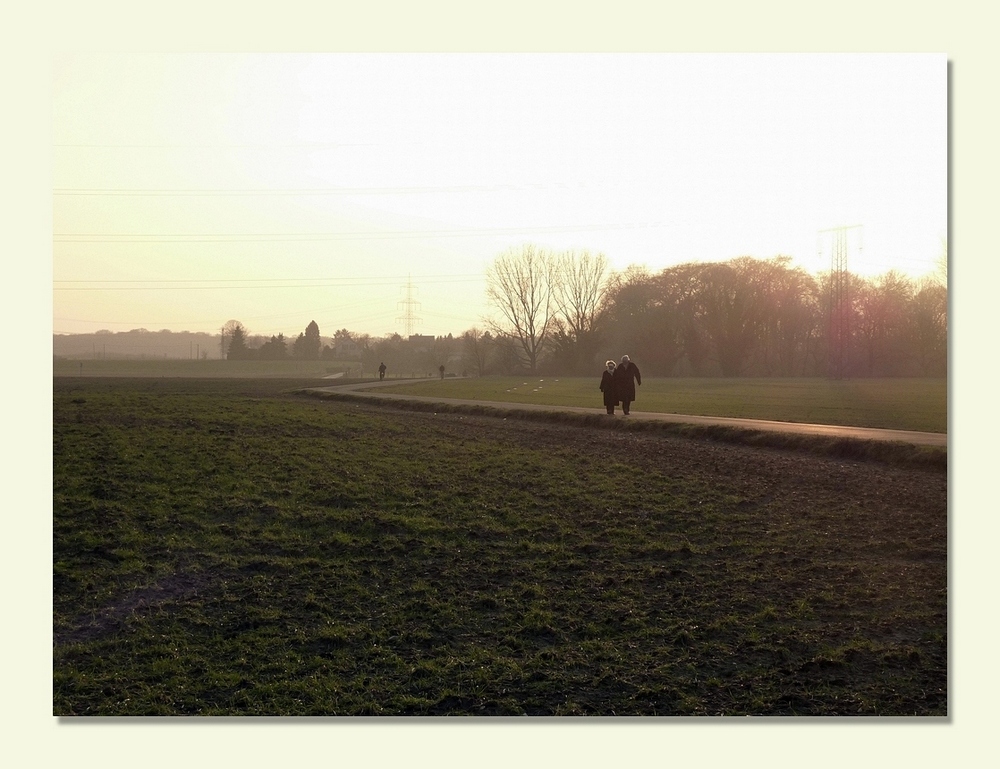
[486,244,555,371]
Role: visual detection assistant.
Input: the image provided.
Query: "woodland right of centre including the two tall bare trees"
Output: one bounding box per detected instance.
[469,252,948,378]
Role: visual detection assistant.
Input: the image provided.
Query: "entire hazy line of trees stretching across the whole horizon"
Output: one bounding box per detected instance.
[53,258,948,377]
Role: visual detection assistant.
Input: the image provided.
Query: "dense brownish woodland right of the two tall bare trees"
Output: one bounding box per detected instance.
[584,257,948,377]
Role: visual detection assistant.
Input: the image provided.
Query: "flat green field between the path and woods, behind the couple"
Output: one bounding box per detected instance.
[366,376,948,433]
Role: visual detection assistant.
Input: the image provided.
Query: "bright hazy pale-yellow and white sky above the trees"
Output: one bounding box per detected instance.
[53,54,948,336]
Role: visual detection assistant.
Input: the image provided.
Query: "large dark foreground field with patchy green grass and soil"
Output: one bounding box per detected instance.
[53,377,948,716]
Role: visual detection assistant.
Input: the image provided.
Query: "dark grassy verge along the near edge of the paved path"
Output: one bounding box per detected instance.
[300,390,948,472]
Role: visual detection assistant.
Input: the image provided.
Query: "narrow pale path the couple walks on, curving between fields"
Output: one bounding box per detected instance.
[308,381,948,447]
